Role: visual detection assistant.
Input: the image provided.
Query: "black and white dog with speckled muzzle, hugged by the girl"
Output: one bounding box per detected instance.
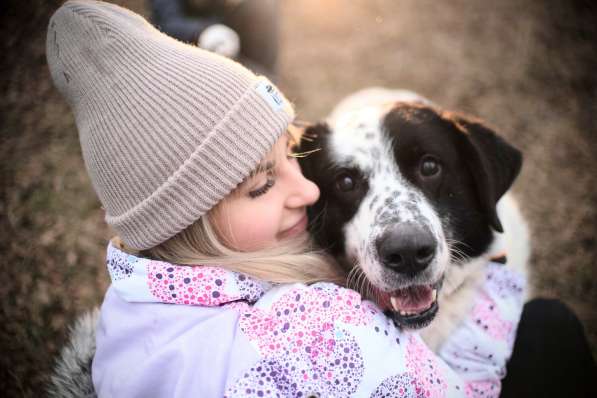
[301,89,530,349]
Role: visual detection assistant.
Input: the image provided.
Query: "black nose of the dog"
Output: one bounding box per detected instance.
[375,224,436,275]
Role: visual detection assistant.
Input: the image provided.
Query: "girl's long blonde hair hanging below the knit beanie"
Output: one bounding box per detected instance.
[115,128,346,285]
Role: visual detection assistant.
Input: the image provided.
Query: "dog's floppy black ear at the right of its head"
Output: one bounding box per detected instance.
[449,115,522,232]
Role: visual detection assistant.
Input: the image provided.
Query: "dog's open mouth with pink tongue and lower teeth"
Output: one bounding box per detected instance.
[384,280,441,329]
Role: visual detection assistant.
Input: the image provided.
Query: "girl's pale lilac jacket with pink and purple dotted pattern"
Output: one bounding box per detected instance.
[92,245,524,397]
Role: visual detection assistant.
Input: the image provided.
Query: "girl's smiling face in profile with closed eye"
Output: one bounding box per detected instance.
[211,134,319,252]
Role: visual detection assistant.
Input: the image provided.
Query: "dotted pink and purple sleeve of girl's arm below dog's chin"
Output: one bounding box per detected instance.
[226,283,461,397]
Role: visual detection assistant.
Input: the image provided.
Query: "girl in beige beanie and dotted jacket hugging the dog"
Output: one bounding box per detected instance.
[47,0,523,397]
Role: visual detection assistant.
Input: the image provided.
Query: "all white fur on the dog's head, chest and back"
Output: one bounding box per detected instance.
[327,88,530,351]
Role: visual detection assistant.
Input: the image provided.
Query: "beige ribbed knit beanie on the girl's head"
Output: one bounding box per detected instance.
[46,0,294,250]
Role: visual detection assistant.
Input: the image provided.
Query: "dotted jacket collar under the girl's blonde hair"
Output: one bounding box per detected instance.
[106,242,271,306]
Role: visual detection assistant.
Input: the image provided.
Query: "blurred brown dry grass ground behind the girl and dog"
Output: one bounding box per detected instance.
[0,0,597,397]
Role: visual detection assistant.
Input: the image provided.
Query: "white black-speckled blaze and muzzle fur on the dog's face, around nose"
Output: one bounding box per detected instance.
[330,106,449,290]
